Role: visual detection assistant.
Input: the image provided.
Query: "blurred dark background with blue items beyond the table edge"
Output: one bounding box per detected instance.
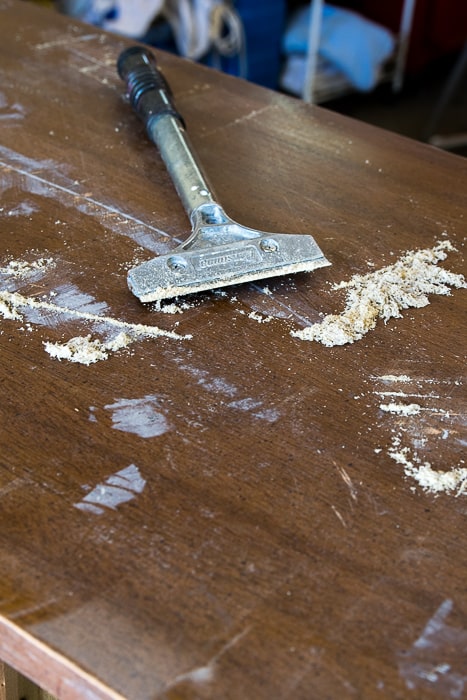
[28,0,467,156]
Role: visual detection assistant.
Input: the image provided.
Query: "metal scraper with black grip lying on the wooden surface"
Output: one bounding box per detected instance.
[117,46,331,302]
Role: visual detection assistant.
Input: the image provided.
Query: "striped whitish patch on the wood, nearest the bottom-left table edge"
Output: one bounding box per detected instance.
[74,464,146,515]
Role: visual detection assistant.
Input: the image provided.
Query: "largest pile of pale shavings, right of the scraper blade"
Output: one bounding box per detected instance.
[291,241,467,347]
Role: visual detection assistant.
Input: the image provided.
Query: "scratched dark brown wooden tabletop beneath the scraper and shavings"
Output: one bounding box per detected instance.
[0,0,467,700]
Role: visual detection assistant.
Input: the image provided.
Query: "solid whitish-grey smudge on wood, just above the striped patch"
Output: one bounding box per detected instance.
[104,396,171,438]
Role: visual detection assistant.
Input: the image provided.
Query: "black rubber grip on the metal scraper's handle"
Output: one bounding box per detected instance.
[117,46,185,135]
